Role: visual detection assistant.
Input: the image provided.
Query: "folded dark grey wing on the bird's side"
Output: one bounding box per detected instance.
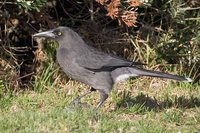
[76,52,144,72]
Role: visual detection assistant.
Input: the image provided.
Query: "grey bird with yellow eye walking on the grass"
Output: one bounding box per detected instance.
[32,26,192,109]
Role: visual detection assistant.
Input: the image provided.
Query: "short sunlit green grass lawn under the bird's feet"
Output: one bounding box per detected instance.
[0,79,200,133]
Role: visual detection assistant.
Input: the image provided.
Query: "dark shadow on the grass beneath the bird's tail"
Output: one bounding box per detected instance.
[117,93,200,111]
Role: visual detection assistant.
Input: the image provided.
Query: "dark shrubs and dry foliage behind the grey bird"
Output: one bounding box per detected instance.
[0,0,200,96]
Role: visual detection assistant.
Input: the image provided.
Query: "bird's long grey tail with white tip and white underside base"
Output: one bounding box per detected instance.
[112,67,192,82]
